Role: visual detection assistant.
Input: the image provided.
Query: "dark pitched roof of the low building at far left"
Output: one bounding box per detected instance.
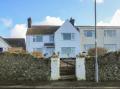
[3,38,26,49]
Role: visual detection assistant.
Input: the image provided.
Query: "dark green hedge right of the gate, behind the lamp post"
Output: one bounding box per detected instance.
[86,52,120,81]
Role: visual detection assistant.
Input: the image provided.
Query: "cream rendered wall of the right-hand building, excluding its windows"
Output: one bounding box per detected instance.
[79,26,120,52]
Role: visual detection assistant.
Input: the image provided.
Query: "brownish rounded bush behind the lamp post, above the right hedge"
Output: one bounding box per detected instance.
[88,47,107,56]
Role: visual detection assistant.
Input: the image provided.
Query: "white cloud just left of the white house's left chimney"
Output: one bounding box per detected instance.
[10,24,27,38]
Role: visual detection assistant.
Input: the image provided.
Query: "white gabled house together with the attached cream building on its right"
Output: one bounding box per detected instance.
[26,18,120,58]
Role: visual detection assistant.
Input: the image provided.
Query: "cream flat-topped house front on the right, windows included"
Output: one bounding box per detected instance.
[78,26,120,52]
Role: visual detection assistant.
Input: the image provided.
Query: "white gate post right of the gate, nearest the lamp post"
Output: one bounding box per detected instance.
[76,54,86,80]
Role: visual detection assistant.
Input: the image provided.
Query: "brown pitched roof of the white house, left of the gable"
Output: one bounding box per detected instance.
[26,25,60,35]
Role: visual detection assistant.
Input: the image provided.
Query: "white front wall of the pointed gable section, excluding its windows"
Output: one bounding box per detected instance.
[54,20,80,57]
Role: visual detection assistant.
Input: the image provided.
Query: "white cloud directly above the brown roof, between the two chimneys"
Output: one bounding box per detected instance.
[38,16,64,25]
